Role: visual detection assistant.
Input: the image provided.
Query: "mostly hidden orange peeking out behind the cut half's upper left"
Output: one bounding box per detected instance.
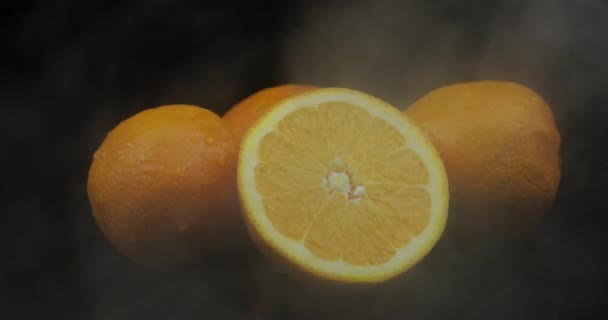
[223,84,317,144]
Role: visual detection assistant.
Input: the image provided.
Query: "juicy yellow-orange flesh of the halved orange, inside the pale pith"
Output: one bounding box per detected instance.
[255,102,431,265]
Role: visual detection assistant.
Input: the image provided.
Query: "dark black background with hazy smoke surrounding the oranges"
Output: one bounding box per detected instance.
[0,0,608,319]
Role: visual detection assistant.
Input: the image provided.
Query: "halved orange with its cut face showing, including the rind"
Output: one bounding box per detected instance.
[238,88,448,283]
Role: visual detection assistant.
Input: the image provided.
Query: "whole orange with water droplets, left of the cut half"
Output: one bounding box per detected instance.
[87,105,239,262]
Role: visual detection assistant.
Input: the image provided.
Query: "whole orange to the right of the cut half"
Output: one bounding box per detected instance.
[405,81,560,239]
